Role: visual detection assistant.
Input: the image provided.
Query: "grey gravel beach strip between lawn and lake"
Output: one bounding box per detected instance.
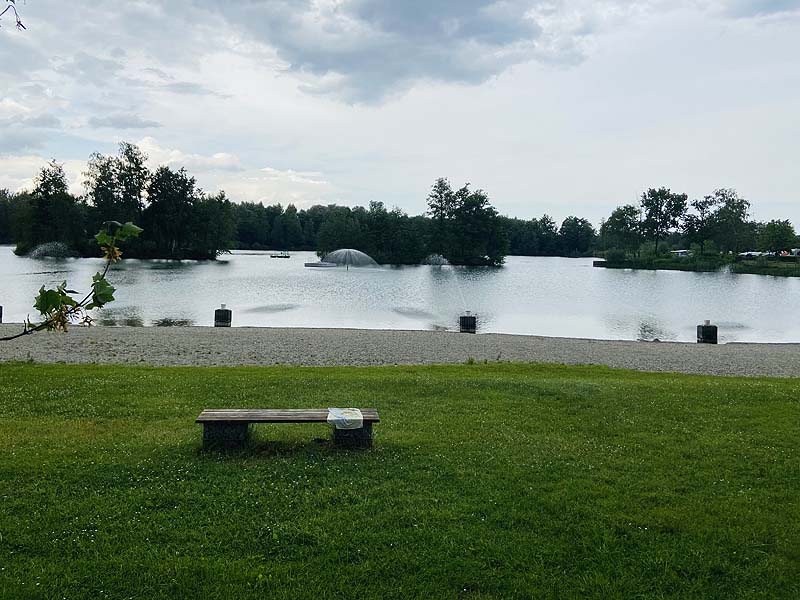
[0,324,800,377]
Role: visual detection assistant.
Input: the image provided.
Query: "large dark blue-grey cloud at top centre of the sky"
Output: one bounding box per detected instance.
[191,0,591,102]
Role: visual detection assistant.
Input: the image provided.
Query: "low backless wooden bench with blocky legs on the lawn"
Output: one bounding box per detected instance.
[195,408,380,448]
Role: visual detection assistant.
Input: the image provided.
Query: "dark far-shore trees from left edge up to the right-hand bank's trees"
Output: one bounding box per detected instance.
[0,142,596,265]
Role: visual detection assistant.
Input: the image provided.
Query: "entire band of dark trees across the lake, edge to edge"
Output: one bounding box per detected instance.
[0,142,800,265]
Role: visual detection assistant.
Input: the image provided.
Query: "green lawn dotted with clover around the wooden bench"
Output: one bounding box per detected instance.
[0,364,800,599]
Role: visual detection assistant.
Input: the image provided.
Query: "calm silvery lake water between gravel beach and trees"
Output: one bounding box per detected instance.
[0,246,800,342]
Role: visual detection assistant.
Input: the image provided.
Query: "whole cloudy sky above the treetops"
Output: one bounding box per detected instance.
[0,0,800,227]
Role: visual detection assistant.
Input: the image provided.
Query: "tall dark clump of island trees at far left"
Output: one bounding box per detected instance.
[0,143,236,259]
